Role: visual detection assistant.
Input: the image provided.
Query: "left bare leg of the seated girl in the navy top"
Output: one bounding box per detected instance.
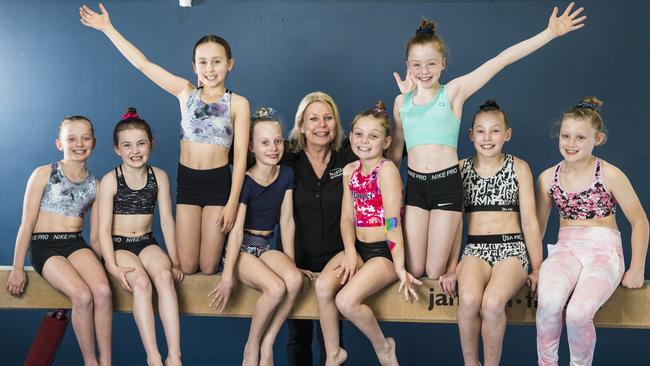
[236,253,286,366]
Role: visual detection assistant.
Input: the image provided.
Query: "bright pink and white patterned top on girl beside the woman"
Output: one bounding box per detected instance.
[348,159,387,227]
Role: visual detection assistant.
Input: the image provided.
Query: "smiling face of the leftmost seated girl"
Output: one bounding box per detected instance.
[56,119,95,162]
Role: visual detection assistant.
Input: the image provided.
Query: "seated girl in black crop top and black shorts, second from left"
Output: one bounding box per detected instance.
[98,108,183,366]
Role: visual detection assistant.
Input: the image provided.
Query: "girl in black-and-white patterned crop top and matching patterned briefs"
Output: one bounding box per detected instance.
[454,100,542,366]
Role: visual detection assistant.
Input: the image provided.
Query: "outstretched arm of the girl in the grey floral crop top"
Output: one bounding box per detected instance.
[79,3,194,98]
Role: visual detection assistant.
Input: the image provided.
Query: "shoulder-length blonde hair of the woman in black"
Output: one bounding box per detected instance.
[289,91,343,153]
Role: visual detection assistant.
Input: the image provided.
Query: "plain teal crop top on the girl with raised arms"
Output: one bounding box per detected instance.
[399,85,460,150]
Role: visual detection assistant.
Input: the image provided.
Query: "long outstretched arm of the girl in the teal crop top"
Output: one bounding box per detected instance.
[447,3,587,107]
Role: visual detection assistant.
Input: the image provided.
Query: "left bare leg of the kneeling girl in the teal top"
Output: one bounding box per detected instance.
[404,206,429,277]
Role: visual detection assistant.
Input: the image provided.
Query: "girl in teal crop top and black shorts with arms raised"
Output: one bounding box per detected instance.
[389,3,586,286]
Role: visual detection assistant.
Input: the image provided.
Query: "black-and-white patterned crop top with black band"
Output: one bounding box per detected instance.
[460,154,519,212]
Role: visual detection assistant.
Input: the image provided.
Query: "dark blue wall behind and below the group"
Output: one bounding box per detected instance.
[0,0,650,365]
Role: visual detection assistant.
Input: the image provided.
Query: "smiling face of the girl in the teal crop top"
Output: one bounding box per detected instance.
[406,42,445,88]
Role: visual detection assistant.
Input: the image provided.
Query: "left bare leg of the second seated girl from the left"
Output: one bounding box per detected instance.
[115,250,162,366]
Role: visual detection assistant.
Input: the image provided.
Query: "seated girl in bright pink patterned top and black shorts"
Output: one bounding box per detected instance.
[315,102,422,366]
